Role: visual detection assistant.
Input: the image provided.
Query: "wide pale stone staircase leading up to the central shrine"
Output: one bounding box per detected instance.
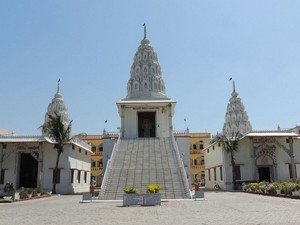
[99,138,189,200]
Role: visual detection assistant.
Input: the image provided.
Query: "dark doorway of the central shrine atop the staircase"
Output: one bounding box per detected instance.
[138,112,155,137]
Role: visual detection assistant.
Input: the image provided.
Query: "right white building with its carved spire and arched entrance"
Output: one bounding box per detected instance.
[204,83,300,190]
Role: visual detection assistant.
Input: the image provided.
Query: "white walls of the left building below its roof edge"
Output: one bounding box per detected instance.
[2,142,91,194]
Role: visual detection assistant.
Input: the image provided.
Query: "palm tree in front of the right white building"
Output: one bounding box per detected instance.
[215,132,241,190]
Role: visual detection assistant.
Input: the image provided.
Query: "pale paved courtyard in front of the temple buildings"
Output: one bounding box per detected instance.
[0,192,300,225]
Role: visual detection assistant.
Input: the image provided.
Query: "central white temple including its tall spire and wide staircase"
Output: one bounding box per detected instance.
[100,26,190,199]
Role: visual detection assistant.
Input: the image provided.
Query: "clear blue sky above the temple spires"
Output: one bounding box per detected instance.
[0,0,300,135]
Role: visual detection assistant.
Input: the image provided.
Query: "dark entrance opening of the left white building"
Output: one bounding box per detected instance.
[19,153,38,188]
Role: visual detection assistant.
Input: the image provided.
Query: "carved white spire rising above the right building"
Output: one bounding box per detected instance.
[223,81,252,137]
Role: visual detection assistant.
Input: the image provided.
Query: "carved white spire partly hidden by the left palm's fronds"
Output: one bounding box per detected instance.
[44,80,70,134]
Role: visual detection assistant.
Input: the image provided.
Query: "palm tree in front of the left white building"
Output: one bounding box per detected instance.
[42,113,72,194]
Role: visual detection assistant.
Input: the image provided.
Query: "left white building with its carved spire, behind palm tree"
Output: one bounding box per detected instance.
[0,82,92,194]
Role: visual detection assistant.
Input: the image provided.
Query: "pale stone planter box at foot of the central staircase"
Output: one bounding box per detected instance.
[123,193,161,206]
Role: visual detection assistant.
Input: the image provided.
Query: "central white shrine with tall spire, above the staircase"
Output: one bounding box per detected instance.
[117,25,176,138]
